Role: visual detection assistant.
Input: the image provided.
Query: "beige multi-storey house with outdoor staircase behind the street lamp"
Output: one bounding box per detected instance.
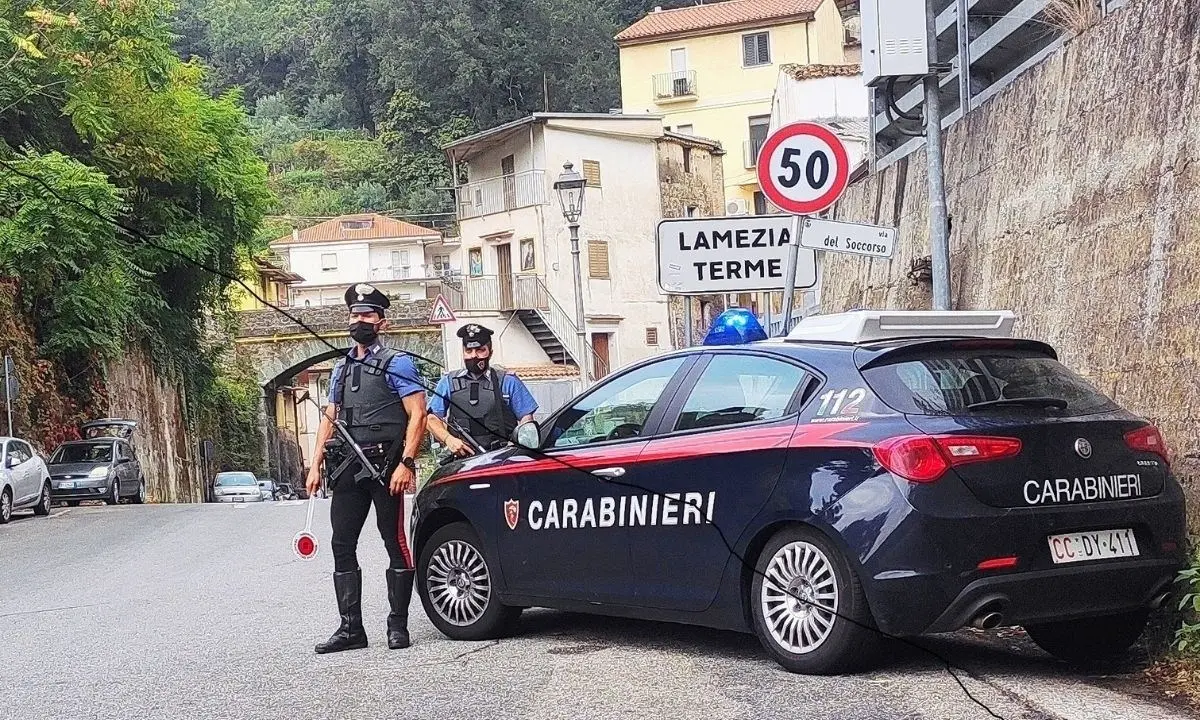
[443,113,724,378]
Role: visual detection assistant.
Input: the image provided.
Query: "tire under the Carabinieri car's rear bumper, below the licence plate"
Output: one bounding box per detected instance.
[1025,610,1150,666]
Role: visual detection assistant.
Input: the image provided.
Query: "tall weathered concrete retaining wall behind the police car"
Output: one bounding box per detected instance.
[822,0,1200,527]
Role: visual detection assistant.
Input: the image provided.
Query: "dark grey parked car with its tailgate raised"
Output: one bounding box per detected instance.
[47,418,146,505]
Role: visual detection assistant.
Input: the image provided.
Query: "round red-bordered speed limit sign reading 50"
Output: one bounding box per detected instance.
[758,122,850,215]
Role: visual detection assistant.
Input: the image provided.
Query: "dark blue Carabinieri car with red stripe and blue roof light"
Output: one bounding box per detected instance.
[414,311,1184,673]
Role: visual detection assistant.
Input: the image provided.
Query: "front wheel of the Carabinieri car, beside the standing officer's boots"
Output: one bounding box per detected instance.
[416,522,521,640]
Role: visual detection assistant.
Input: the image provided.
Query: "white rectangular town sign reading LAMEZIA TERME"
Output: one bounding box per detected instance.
[656,215,817,295]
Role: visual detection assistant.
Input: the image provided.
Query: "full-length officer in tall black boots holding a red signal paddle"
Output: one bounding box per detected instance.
[306,283,426,653]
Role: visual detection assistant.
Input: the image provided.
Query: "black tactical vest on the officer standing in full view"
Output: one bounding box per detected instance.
[338,348,408,445]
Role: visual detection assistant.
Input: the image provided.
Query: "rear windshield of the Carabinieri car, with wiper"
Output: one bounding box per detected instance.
[863,350,1117,416]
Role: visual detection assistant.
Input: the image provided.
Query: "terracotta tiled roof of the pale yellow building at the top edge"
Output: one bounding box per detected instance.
[617,0,822,42]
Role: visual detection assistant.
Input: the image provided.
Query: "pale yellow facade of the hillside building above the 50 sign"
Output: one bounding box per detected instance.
[620,0,844,206]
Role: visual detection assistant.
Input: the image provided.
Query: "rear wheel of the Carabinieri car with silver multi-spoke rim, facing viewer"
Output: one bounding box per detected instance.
[746,527,878,674]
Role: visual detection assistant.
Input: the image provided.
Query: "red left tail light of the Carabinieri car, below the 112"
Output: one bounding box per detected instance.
[874,436,1021,482]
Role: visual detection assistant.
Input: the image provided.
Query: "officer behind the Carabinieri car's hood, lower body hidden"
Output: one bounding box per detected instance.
[427,323,538,455]
